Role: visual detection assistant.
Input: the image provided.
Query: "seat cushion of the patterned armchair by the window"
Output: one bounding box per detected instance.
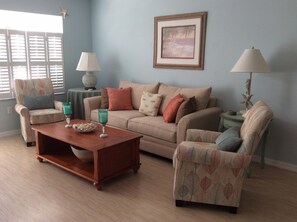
[29,109,65,124]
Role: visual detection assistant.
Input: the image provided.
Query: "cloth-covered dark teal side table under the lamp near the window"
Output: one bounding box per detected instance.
[67,88,100,119]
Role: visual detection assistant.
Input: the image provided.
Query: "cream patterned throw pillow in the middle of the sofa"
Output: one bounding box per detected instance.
[139,91,162,116]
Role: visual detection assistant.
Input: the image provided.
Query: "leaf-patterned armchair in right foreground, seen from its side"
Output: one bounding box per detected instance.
[173,101,273,213]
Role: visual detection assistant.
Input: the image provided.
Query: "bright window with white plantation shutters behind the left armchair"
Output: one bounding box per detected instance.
[0,10,65,99]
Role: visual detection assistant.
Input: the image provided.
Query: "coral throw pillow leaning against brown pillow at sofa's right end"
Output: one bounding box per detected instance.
[163,94,184,123]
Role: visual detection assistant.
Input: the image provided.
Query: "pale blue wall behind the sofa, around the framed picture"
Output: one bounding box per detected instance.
[91,0,297,165]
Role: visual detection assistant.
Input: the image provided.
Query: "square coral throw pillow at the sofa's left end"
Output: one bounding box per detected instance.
[107,87,133,111]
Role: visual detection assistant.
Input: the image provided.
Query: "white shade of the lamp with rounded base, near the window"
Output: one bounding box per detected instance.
[76,52,101,72]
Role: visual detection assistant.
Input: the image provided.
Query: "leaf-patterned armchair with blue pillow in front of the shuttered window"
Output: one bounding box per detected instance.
[14,78,64,146]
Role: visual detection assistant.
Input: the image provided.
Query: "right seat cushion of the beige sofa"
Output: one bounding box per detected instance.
[128,116,177,143]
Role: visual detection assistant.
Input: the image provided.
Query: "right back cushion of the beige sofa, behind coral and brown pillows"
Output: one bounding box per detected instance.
[158,83,211,115]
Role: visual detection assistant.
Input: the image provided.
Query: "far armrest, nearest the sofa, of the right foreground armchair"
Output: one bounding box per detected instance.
[186,129,221,143]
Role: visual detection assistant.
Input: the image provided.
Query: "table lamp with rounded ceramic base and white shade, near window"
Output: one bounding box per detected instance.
[76,52,101,90]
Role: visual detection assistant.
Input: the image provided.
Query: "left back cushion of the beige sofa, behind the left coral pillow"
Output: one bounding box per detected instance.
[119,80,159,109]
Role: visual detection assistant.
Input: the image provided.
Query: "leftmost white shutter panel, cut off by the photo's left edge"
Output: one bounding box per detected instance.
[0,30,11,99]
